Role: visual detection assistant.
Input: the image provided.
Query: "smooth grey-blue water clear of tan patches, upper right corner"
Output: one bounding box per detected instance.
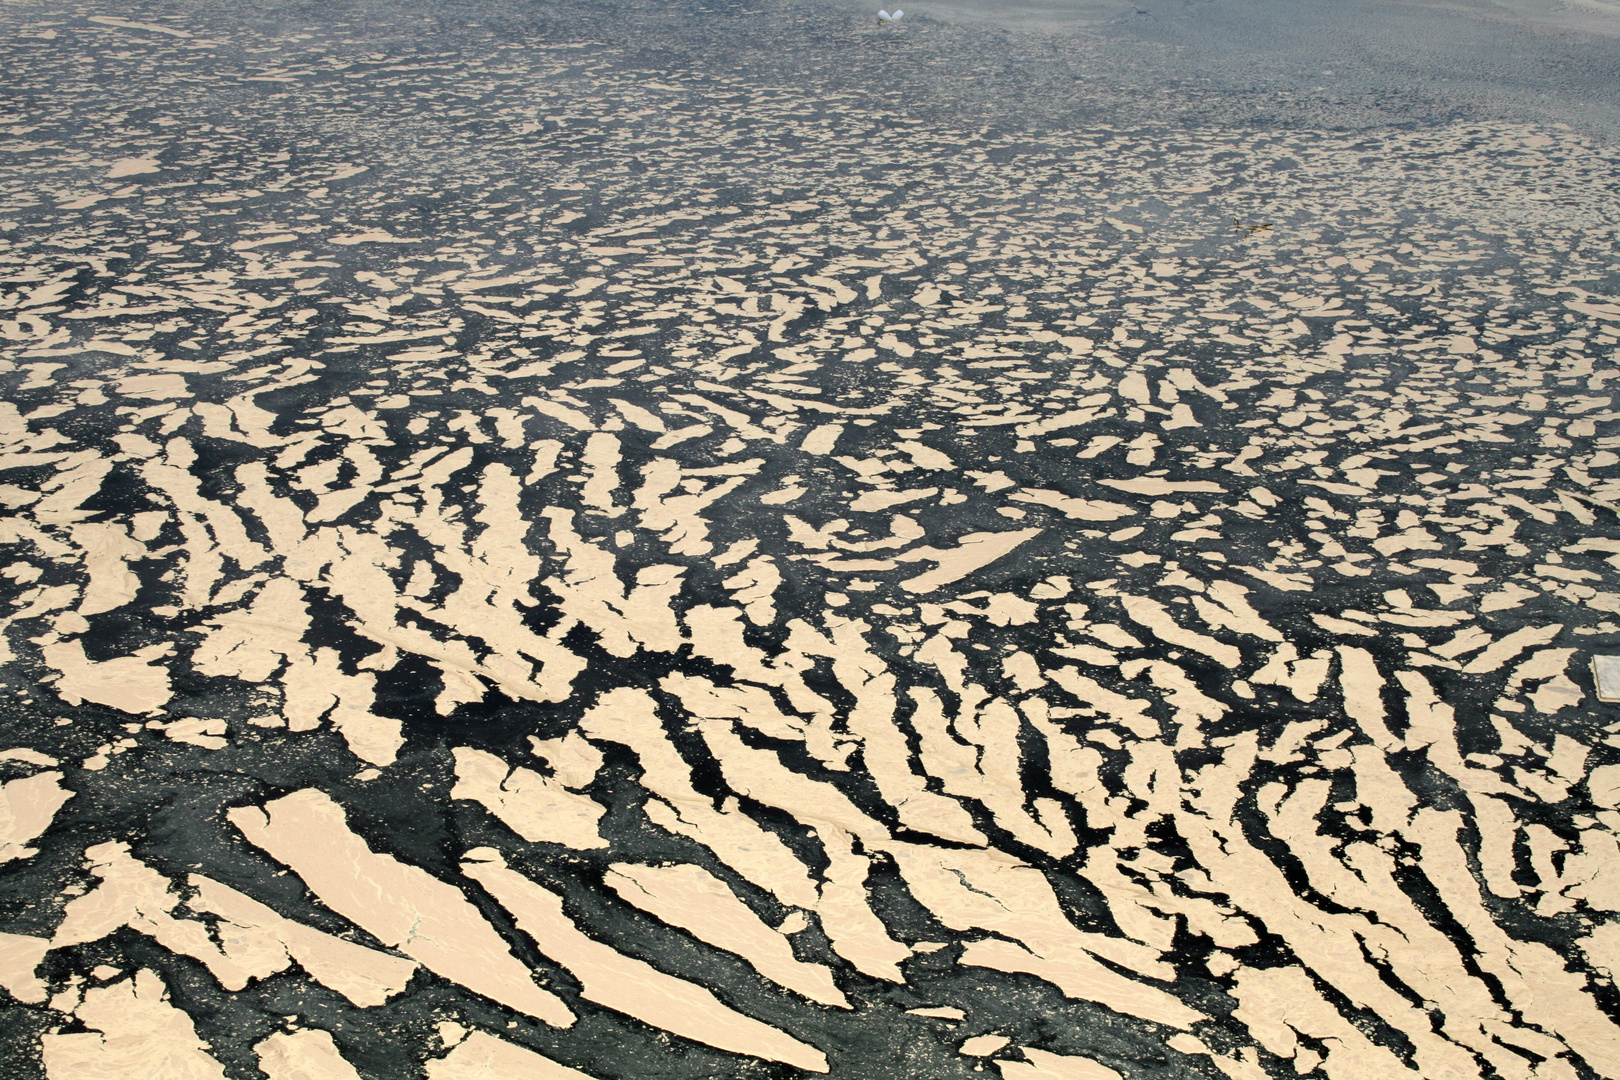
[806,0,1620,138]
